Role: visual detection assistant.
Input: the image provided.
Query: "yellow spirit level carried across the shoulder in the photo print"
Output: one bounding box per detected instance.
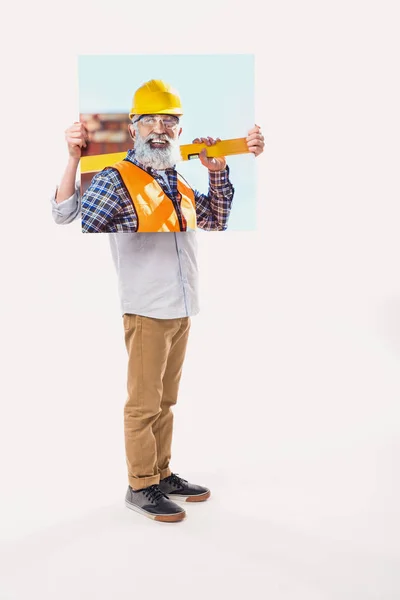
[81,138,249,173]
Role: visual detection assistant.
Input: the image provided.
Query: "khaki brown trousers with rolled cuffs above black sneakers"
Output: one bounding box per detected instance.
[123,314,190,490]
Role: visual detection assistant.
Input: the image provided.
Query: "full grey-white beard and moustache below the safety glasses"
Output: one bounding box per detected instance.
[134,126,182,171]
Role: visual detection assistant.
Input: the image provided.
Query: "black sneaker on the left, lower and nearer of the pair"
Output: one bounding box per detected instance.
[125,485,186,523]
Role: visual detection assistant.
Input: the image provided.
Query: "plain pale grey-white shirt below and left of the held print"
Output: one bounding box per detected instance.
[51,184,199,319]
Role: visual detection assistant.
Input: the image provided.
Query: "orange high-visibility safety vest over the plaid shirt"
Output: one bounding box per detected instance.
[111,160,196,232]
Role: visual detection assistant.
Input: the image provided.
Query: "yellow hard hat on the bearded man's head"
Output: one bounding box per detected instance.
[129,79,183,119]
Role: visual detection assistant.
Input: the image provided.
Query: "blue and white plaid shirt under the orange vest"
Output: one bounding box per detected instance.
[82,150,234,233]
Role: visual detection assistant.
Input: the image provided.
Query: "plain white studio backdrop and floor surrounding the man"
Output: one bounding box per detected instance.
[0,0,400,600]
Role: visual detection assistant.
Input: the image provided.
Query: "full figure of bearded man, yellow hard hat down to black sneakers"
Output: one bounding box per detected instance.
[51,80,264,522]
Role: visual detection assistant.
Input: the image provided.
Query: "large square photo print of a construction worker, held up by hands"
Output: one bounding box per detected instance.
[76,55,259,233]
